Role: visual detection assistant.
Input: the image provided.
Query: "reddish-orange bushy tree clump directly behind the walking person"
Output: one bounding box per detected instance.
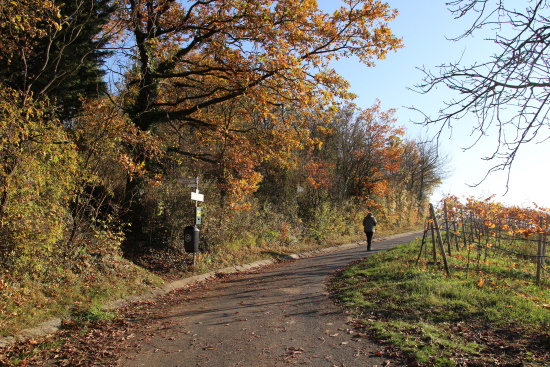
[298,102,447,227]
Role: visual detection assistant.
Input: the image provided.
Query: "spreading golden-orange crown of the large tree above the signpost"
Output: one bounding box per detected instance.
[108,0,400,244]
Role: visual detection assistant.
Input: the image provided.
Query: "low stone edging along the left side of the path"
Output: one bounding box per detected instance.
[0,231,422,348]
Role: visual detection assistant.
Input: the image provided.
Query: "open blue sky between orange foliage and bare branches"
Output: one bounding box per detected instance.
[319,0,550,208]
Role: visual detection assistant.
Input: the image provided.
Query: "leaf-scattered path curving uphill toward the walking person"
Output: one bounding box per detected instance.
[119,234,418,367]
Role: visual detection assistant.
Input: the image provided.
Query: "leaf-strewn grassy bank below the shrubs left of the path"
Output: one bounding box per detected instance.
[0,258,162,336]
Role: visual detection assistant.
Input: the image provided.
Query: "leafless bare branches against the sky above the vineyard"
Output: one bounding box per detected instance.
[417,0,550,187]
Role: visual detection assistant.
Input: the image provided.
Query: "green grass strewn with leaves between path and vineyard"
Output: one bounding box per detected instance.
[329,237,550,366]
